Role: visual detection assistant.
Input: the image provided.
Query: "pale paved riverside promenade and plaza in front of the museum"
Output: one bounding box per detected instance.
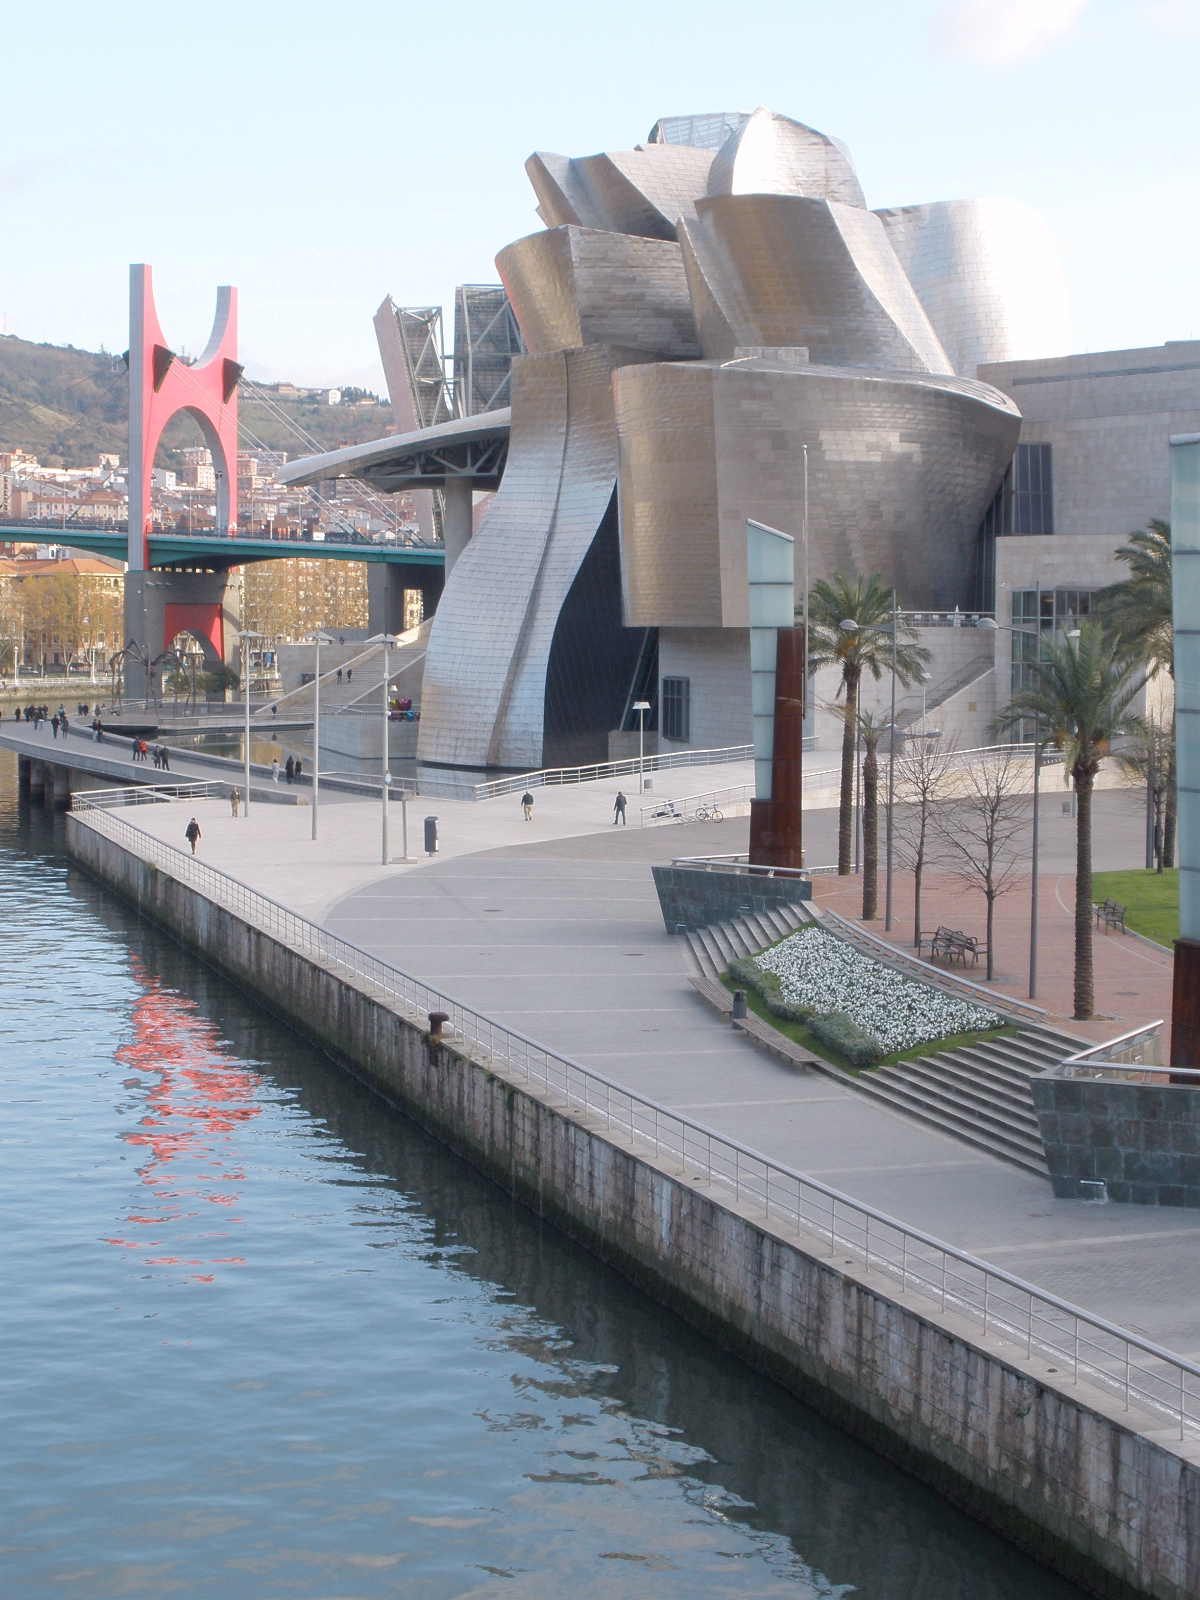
[112,768,1200,1358]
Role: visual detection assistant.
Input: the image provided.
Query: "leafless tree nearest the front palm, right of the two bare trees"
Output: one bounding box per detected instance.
[936,746,1029,982]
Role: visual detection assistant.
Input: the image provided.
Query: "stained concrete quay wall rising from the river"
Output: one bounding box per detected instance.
[67,814,1200,1600]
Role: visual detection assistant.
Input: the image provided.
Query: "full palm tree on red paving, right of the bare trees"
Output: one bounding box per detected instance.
[992,619,1146,1022]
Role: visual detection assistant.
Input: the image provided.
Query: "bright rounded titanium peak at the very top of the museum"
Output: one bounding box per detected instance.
[709,106,867,210]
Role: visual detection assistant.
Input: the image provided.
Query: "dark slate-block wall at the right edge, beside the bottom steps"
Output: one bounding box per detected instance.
[1030,1072,1200,1206]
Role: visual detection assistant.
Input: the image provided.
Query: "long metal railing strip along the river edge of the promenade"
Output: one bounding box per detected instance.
[72,792,1200,1438]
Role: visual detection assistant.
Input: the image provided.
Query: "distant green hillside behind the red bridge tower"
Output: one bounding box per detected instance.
[0,336,392,467]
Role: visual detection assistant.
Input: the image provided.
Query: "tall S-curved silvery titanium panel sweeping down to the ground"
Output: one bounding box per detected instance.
[418,346,616,770]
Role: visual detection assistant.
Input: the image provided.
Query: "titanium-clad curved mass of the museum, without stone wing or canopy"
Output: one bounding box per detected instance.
[418,107,1058,768]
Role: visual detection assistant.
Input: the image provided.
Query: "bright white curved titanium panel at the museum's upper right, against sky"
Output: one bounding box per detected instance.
[875,200,1070,378]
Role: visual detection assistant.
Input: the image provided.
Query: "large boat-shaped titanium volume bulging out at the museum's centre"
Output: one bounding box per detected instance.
[614,360,1021,627]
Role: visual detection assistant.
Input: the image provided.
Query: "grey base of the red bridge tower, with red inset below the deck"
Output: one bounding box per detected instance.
[125,568,242,699]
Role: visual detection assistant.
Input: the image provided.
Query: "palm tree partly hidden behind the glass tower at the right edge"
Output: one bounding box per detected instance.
[1091,517,1176,870]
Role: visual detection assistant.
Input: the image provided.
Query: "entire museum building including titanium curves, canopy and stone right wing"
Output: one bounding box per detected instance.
[280,107,1200,768]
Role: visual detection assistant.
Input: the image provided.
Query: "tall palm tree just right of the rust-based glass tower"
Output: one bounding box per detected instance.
[809,573,933,877]
